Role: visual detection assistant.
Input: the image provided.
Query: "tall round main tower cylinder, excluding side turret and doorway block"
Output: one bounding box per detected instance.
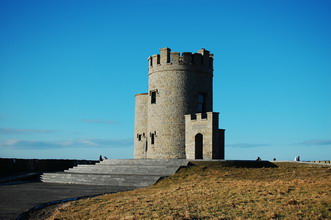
[146,48,213,159]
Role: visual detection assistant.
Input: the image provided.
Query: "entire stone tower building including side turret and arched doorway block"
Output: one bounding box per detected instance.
[134,48,224,159]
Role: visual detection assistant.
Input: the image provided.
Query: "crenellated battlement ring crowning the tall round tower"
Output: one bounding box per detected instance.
[148,48,213,72]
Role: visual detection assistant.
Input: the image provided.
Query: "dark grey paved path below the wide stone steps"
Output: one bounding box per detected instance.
[0,182,128,220]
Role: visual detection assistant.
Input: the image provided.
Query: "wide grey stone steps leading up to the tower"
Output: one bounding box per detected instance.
[41,159,189,190]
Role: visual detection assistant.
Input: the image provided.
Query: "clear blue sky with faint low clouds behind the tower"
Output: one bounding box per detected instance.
[0,0,331,160]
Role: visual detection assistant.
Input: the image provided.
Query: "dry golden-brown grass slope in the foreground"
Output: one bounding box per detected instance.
[40,163,331,219]
